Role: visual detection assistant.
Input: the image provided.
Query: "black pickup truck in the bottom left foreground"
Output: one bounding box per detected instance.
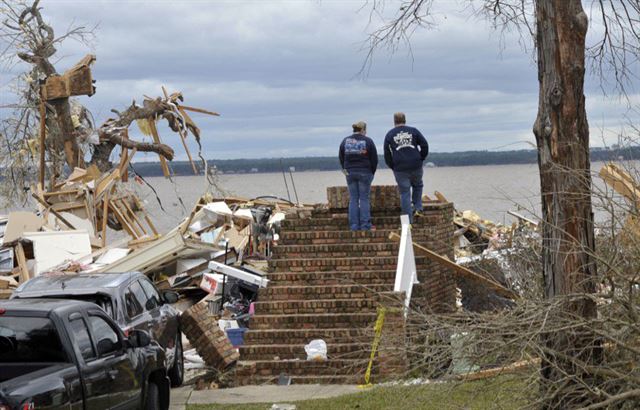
[0,299,170,410]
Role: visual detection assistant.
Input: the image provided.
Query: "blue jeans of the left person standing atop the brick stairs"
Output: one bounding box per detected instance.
[347,170,373,231]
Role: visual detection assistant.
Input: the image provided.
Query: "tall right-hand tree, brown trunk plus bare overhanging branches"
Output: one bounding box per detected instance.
[366,0,640,408]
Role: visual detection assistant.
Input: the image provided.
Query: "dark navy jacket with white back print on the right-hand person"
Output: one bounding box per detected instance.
[384,125,429,171]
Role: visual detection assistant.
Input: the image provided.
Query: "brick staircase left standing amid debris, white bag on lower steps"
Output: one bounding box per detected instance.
[236,187,455,385]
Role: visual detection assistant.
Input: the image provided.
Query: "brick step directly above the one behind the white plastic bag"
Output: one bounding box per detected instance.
[244,327,373,345]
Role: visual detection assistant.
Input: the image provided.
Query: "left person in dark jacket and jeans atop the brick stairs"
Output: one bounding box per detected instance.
[339,121,378,231]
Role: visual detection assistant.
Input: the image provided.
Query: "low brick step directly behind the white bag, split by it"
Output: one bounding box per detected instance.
[240,341,371,360]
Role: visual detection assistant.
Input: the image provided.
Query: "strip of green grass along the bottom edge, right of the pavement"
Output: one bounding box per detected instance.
[187,376,526,410]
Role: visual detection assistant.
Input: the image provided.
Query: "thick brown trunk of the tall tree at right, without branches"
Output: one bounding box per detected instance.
[533,0,598,408]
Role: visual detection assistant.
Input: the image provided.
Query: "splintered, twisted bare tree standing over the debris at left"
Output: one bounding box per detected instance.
[0,0,217,203]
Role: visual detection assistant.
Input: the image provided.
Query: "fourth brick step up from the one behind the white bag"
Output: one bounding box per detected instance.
[258,283,393,302]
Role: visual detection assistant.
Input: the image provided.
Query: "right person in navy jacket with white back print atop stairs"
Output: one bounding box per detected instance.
[384,112,429,223]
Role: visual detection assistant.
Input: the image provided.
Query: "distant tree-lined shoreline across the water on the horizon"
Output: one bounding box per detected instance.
[127,147,640,177]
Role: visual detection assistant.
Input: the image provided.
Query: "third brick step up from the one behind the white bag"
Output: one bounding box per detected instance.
[255,293,393,315]
